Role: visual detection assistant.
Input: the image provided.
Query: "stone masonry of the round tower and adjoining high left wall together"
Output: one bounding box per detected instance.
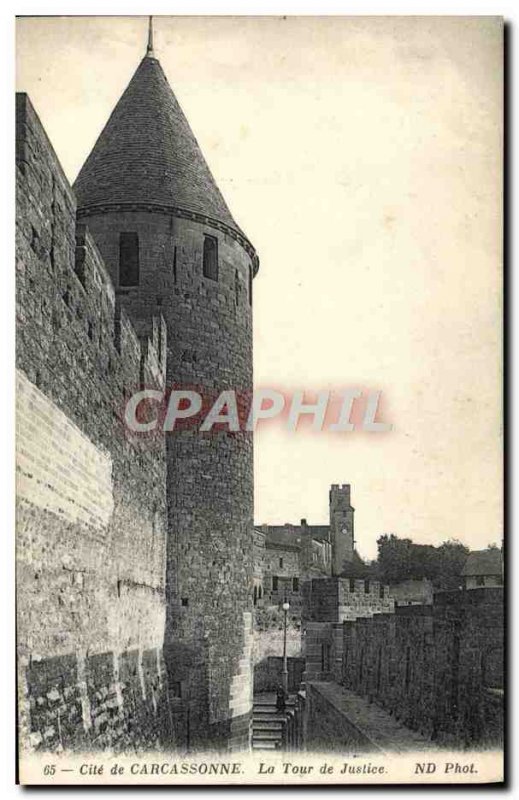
[17,34,258,749]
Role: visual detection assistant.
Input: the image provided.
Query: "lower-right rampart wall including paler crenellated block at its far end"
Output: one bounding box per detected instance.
[303,578,503,746]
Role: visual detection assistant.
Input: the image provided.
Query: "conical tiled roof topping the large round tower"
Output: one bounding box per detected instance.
[74,55,244,236]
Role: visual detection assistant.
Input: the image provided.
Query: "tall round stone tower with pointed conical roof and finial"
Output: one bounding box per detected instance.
[74,24,258,748]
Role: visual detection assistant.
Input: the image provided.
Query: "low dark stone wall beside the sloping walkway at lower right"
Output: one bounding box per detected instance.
[340,589,504,746]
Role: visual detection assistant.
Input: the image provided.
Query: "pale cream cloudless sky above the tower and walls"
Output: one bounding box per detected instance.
[17,17,502,558]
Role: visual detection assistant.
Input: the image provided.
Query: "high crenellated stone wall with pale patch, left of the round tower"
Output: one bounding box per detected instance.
[16,95,172,750]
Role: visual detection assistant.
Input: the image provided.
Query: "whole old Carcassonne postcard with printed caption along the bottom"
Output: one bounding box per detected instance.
[16,16,505,785]
